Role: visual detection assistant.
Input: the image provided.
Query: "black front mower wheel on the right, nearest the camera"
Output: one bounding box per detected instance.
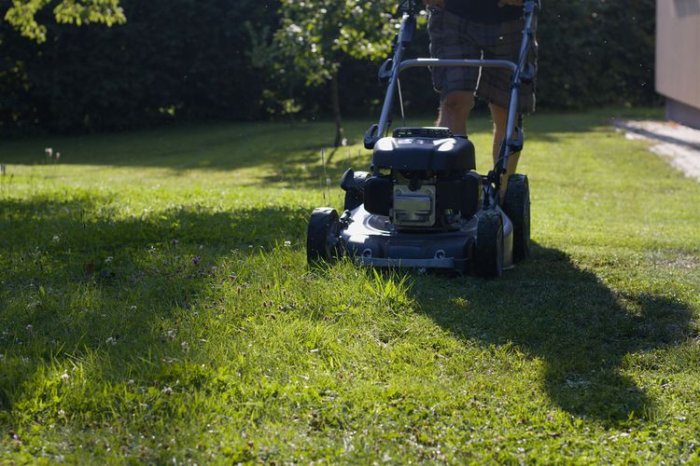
[474,209,503,278]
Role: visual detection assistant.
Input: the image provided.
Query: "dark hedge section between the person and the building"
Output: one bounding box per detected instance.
[537,0,658,108]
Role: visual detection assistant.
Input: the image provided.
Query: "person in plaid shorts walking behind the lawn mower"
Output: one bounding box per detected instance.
[423,0,537,199]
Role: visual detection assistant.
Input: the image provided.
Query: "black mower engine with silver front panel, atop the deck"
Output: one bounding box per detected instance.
[341,128,482,231]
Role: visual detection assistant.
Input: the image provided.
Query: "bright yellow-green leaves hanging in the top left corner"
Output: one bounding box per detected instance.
[5,0,126,42]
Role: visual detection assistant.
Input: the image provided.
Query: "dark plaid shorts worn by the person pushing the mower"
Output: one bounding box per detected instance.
[428,8,537,113]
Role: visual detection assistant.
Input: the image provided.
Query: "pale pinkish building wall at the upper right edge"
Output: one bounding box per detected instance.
[656,0,700,126]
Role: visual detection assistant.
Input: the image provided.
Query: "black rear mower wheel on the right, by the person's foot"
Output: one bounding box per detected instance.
[503,174,530,262]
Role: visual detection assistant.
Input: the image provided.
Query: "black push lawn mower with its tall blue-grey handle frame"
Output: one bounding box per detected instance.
[306,0,539,278]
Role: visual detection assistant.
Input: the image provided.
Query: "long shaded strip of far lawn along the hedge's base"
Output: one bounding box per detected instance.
[0,113,607,177]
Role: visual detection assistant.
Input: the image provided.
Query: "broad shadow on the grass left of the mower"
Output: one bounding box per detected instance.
[0,196,308,414]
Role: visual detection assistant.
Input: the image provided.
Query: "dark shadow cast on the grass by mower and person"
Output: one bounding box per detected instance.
[417,245,691,422]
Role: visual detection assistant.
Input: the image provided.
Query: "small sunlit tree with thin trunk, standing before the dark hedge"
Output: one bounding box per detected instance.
[274,0,398,147]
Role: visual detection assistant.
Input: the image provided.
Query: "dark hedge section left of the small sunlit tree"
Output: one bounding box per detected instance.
[0,0,276,132]
